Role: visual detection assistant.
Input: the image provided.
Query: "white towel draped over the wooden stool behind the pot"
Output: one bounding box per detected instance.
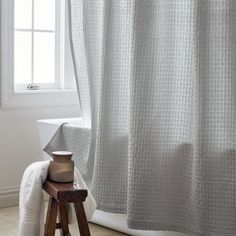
[18,161,97,236]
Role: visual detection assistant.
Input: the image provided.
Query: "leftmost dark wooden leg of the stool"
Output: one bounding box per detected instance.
[44,197,58,236]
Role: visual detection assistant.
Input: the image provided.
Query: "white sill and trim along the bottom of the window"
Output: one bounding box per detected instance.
[1,89,79,108]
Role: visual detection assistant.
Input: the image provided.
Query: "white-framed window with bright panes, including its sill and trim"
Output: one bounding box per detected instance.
[1,0,78,107]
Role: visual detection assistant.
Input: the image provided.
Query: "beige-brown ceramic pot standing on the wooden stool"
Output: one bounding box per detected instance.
[49,151,74,183]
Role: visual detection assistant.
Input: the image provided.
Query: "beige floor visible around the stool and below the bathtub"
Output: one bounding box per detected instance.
[0,207,127,236]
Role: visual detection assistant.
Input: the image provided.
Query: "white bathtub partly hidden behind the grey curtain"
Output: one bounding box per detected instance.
[38,118,186,236]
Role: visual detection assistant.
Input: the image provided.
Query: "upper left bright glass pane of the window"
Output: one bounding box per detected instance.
[14,0,32,29]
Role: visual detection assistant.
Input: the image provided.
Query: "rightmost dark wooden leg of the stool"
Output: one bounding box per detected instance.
[74,201,90,236]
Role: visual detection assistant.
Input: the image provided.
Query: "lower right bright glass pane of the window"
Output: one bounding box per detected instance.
[34,32,55,83]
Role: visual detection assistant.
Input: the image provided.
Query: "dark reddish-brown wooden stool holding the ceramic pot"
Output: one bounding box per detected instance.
[43,180,90,236]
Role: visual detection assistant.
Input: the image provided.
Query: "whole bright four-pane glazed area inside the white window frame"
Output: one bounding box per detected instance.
[14,0,58,88]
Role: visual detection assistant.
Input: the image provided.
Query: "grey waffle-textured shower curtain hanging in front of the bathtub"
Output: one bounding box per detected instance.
[69,0,236,236]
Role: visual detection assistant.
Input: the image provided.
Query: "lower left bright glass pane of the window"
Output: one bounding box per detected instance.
[14,32,32,84]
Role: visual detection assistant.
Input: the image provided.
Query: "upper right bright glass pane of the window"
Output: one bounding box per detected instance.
[34,0,55,30]
